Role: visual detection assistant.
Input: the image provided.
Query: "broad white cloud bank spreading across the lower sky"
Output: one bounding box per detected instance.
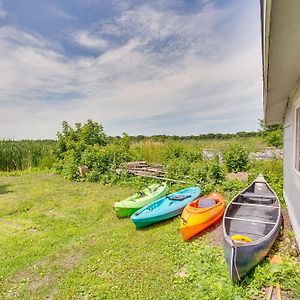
[0,0,261,138]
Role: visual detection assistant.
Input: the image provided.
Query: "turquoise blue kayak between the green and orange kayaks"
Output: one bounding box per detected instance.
[131,187,201,228]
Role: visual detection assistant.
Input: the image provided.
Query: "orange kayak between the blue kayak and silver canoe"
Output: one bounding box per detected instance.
[179,193,225,240]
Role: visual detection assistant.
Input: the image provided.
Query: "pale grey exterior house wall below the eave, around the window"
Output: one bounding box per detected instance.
[283,80,300,246]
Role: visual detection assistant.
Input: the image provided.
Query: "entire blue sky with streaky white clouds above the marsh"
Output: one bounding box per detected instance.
[0,0,262,139]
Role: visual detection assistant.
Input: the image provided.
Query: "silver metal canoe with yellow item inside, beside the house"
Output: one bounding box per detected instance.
[223,174,281,282]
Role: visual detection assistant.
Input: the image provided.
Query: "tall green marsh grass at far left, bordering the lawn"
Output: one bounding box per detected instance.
[0,140,56,171]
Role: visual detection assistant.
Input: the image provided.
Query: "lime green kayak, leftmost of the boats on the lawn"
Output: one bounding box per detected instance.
[114,183,169,218]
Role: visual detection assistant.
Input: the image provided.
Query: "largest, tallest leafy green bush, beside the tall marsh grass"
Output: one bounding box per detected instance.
[56,120,131,182]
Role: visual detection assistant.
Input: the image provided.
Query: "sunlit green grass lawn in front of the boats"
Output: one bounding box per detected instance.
[0,172,300,299]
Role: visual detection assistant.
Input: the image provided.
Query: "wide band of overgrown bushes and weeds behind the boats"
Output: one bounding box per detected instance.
[55,120,268,185]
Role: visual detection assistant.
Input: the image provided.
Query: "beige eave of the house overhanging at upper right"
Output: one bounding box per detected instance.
[261,0,300,125]
